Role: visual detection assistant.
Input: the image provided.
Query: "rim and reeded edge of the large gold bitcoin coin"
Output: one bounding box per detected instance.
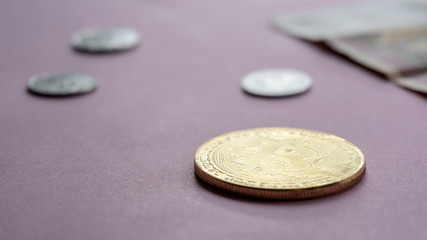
[194,127,366,200]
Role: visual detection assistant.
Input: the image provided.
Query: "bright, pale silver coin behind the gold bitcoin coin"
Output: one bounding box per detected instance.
[241,69,312,97]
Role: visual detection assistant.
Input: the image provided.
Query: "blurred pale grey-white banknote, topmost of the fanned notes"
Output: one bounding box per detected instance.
[271,0,427,41]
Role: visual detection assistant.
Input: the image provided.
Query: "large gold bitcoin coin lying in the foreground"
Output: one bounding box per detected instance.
[195,128,365,200]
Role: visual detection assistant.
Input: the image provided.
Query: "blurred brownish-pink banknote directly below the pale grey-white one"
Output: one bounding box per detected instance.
[326,26,427,78]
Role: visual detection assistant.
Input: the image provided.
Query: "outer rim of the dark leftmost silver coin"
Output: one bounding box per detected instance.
[27,72,98,96]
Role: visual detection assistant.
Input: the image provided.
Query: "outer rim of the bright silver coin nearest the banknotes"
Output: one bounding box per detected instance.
[240,68,313,97]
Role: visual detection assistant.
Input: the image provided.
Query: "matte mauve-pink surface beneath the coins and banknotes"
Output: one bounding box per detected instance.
[0,0,427,240]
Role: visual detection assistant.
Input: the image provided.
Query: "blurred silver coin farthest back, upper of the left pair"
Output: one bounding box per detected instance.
[71,27,140,53]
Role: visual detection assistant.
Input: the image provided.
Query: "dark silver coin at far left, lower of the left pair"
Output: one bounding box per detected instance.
[27,73,97,96]
